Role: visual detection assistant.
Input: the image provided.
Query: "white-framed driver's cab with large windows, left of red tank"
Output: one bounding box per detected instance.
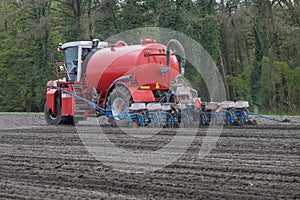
[58,39,108,82]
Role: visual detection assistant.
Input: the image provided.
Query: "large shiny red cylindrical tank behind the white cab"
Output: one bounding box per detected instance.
[85,40,179,97]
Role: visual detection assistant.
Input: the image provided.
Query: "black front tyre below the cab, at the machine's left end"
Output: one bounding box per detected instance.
[45,95,62,126]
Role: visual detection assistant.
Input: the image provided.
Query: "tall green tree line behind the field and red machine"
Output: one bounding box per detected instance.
[0,0,300,114]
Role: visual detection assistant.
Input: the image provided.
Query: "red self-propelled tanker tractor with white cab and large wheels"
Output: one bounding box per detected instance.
[45,39,201,127]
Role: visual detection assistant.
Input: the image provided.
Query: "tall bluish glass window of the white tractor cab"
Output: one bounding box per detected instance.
[64,47,78,81]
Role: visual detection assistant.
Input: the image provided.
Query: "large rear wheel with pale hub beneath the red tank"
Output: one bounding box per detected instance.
[107,85,132,127]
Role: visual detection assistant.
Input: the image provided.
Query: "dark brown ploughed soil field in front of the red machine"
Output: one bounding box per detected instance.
[0,115,300,199]
